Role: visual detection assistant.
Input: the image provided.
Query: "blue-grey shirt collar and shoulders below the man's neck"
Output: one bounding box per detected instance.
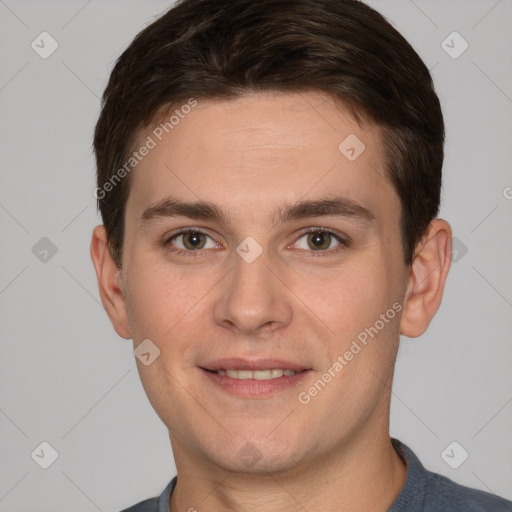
[121,438,512,512]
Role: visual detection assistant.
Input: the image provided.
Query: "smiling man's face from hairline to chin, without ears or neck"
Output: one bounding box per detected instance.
[121,92,407,472]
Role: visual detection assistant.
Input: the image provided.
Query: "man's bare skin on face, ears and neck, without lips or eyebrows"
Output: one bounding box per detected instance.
[91,91,451,512]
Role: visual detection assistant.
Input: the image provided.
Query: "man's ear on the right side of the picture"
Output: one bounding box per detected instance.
[400,219,452,338]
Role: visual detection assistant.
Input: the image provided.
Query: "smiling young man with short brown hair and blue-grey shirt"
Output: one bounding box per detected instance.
[91,0,512,512]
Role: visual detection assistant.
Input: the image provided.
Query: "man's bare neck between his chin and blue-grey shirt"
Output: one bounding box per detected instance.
[171,431,407,512]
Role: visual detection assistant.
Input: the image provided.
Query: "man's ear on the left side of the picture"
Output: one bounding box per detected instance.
[91,226,131,339]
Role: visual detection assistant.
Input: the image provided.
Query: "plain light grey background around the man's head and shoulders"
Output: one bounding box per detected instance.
[0,0,512,512]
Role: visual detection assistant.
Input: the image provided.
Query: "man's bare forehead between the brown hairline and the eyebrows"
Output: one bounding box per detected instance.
[129,92,396,223]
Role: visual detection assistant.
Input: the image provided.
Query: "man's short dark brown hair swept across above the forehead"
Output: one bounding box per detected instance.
[94,0,445,267]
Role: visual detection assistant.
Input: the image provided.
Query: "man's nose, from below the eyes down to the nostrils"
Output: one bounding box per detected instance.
[214,243,293,336]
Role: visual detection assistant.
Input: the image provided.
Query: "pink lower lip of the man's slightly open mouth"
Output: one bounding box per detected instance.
[200,368,311,398]
